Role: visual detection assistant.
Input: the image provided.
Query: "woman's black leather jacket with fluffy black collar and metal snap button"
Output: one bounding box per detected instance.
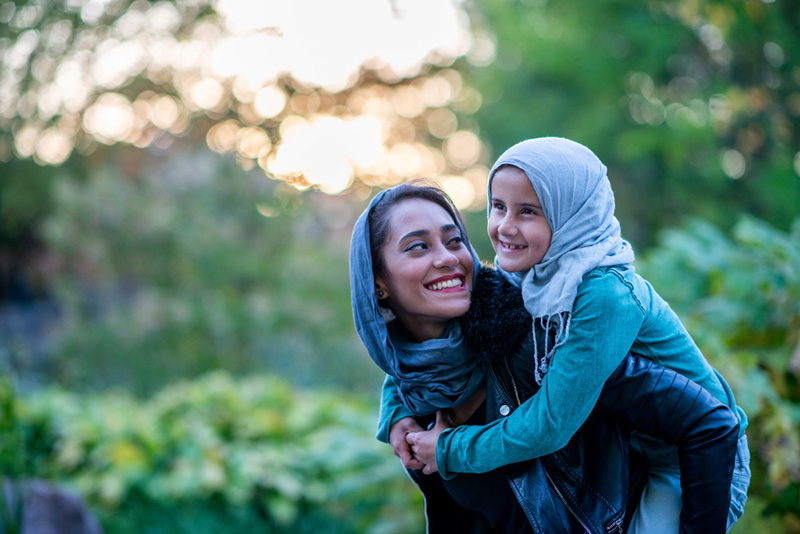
[412,268,738,534]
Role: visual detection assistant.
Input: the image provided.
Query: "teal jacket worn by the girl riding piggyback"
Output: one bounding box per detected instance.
[378,266,747,478]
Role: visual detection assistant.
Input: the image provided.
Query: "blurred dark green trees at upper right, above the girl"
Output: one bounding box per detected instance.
[464,0,800,246]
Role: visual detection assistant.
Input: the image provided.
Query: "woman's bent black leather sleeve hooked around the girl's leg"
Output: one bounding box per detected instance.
[598,354,739,534]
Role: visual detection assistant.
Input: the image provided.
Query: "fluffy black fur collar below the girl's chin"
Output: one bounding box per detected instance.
[461,265,531,360]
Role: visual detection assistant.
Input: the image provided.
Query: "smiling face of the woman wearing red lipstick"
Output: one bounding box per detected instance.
[375,198,474,342]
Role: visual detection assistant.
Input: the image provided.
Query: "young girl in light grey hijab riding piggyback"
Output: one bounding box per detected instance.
[408,137,750,533]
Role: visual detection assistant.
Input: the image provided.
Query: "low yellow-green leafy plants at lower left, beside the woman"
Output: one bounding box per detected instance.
[12,372,422,534]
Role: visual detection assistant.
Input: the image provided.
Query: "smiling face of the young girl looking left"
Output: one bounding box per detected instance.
[487,165,553,272]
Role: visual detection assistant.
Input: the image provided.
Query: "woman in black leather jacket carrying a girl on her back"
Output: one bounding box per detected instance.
[350,185,737,532]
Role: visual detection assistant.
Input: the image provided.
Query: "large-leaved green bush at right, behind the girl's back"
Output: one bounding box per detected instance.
[639,217,800,532]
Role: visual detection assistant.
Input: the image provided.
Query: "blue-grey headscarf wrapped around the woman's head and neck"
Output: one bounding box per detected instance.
[350,189,485,415]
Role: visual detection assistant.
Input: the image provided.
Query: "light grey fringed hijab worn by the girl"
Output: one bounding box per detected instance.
[489,137,634,384]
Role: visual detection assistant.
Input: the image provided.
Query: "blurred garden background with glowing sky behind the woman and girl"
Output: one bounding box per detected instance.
[0,0,800,533]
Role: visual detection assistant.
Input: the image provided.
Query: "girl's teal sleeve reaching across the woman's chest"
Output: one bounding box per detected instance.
[436,270,644,478]
